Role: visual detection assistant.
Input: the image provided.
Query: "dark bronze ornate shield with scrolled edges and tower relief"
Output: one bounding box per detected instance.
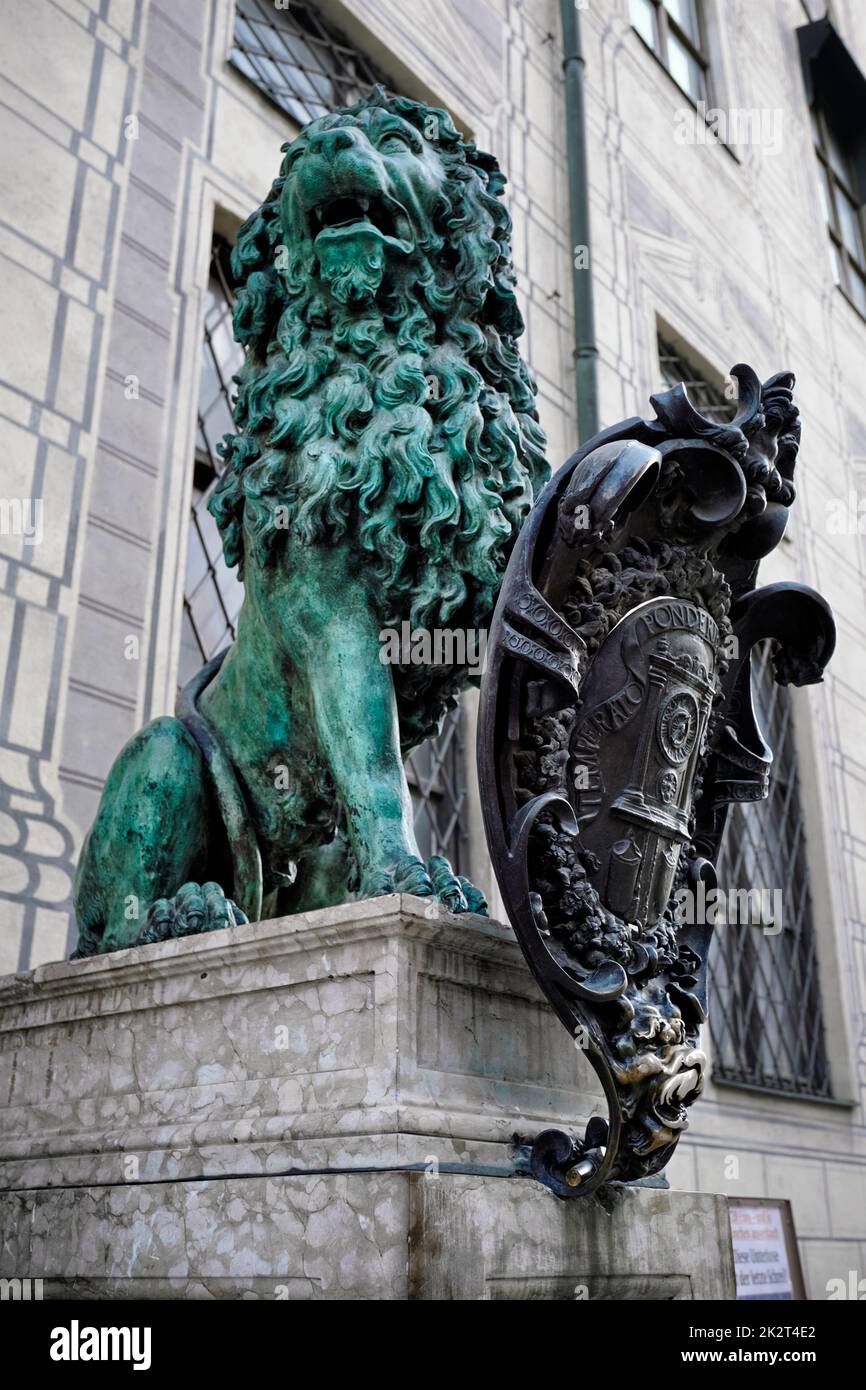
[478,366,834,1197]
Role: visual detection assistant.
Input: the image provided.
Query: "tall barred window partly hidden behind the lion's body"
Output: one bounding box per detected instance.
[178,235,468,874]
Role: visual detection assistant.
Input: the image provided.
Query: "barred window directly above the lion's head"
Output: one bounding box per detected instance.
[231,0,391,125]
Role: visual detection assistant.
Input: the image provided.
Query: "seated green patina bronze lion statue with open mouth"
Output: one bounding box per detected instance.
[75,89,548,955]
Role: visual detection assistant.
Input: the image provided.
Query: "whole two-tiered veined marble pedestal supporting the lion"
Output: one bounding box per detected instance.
[0,897,733,1300]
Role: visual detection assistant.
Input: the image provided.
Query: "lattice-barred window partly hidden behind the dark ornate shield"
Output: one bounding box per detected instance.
[659,336,830,1097]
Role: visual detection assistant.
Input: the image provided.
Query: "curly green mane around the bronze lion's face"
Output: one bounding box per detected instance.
[210,89,548,745]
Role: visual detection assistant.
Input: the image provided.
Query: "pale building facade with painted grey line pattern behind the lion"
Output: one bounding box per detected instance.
[0,0,866,1298]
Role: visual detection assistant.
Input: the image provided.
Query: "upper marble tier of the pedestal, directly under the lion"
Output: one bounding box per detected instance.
[0,895,606,1188]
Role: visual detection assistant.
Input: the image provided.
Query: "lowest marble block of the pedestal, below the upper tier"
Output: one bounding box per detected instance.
[0,1172,734,1301]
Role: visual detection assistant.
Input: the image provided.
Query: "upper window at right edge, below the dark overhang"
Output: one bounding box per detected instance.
[812,104,866,317]
